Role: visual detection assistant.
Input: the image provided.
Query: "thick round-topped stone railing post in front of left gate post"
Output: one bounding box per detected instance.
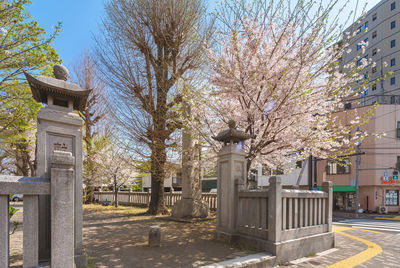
[50,151,75,268]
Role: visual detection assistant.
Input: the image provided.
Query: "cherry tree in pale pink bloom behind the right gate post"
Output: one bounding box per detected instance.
[199,0,372,170]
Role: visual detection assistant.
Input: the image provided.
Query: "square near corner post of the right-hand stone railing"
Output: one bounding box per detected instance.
[268,176,282,243]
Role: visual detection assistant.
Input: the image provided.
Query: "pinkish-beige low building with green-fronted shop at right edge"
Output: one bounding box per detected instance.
[317,104,400,212]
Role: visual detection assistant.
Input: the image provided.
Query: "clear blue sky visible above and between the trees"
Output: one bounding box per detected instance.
[28,0,379,68]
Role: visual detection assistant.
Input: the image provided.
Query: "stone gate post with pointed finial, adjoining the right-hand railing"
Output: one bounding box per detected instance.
[213,120,250,240]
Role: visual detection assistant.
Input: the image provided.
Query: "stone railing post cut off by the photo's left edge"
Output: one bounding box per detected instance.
[0,195,10,267]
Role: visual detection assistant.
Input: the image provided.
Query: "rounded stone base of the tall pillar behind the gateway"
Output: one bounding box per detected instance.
[172,198,210,218]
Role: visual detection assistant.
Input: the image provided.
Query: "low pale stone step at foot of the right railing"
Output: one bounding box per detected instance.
[201,252,276,268]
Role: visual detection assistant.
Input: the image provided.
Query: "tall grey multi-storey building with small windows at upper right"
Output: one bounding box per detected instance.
[342,0,400,108]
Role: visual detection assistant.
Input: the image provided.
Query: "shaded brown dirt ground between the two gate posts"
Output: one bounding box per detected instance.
[10,202,254,268]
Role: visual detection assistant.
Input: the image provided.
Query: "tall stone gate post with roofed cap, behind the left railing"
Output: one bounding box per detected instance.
[25,65,91,268]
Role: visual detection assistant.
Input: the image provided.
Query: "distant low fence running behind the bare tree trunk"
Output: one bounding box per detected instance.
[94,192,217,210]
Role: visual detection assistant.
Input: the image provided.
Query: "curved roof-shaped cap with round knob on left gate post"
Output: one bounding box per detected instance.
[24,64,92,111]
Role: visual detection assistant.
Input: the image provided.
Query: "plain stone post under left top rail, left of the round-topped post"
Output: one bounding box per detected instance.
[23,195,39,267]
